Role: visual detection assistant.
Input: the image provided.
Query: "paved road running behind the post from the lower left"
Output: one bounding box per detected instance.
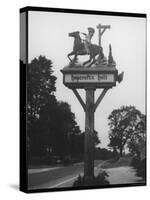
[28,160,104,189]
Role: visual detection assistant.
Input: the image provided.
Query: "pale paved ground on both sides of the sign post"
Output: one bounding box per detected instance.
[28,160,142,189]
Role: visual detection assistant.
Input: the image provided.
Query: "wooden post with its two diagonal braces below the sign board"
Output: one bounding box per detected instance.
[72,87,108,181]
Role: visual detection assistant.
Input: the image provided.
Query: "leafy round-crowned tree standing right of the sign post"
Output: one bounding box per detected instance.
[108,106,142,156]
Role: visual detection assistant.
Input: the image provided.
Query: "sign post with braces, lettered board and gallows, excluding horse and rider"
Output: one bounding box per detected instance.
[61,24,123,185]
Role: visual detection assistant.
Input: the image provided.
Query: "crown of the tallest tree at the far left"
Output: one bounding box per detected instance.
[27,56,56,119]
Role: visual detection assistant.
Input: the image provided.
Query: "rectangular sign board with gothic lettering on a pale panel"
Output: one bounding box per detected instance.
[61,68,118,88]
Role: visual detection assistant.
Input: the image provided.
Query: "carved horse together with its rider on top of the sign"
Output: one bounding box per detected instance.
[68,27,104,67]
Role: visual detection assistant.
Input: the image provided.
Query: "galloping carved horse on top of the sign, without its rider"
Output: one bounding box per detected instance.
[67,31,104,66]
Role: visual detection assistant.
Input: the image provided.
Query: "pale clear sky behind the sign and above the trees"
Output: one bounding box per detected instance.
[21,11,146,147]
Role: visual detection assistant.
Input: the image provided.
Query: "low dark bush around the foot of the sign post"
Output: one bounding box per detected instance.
[73,171,109,187]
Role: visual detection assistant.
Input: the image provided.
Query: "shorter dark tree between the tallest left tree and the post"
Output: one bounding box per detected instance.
[32,99,81,157]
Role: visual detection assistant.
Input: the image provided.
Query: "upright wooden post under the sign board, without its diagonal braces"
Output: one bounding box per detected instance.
[84,88,95,183]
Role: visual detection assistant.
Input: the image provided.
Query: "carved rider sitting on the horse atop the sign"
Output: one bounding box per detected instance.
[82,27,95,54]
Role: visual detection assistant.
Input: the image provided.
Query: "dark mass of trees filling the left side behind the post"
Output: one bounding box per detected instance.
[21,56,99,164]
